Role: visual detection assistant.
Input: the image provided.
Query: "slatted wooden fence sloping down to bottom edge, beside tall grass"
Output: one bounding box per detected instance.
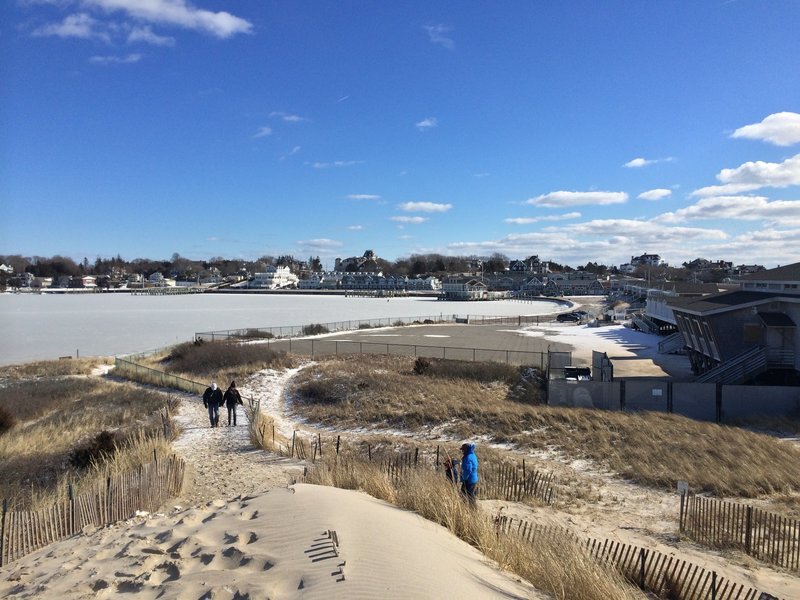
[495,516,778,600]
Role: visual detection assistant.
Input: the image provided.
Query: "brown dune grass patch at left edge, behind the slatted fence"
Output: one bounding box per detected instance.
[0,377,175,507]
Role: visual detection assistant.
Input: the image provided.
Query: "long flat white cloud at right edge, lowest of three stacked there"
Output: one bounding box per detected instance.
[657,196,800,223]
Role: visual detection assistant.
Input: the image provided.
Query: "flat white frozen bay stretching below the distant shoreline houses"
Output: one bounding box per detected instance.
[0,293,559,365]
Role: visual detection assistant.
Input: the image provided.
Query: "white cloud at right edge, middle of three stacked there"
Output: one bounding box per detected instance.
[692,154,800,196]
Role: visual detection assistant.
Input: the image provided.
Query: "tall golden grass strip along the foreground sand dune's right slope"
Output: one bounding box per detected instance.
[307,456,644,600]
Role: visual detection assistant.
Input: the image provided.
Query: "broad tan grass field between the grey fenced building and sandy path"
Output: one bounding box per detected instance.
[292,356,800,498]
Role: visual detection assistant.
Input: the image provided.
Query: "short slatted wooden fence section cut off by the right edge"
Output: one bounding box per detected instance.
[679,494,800,571]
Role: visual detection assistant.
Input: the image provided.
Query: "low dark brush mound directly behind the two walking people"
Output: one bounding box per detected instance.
[154,341,297,385]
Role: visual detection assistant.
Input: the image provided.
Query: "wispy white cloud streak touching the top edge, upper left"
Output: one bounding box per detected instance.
[82,0,248,39]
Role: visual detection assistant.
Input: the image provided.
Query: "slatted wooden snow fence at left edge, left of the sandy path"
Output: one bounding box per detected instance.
[0,455,185,566]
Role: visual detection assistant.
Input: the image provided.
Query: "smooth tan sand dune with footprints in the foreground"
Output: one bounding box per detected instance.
[0,484,543,600]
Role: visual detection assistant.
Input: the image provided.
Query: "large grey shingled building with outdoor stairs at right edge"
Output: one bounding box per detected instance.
[668,263,800,383]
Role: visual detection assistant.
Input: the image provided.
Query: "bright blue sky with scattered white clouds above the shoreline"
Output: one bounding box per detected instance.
[0,0,800,267]
